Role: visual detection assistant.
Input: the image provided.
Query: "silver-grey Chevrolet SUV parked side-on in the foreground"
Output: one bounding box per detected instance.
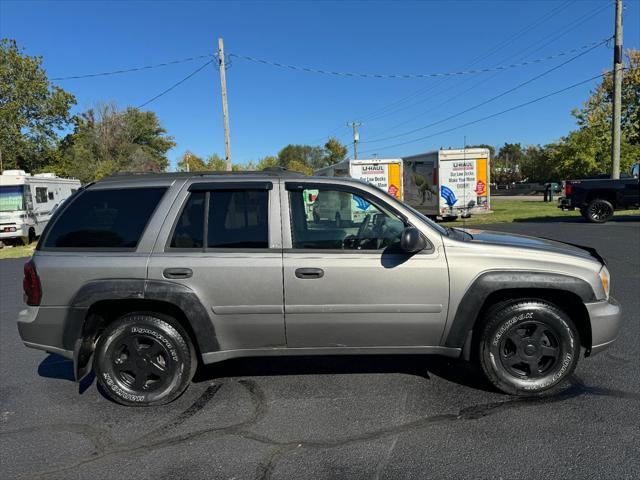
[18,171,620,405]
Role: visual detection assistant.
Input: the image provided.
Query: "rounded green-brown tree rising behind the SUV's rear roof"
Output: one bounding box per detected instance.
[57,104,175,182]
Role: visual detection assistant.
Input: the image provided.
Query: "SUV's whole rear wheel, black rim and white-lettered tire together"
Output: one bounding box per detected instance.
[94,312,197,406]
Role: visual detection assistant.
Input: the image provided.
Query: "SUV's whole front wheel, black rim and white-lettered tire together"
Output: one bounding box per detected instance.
[478,299,580,396]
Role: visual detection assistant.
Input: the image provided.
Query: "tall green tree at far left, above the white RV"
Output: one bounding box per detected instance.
[0,39,76,172]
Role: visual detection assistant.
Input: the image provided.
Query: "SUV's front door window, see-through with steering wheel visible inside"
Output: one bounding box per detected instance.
[289,190,405,250]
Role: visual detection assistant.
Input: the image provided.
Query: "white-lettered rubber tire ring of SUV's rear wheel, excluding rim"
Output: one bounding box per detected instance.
[94,312,195,406]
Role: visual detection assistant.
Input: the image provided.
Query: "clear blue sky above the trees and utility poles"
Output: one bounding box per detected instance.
[0,0,640,171]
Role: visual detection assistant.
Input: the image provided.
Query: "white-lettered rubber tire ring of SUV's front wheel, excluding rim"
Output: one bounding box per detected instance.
[480,300,580,396]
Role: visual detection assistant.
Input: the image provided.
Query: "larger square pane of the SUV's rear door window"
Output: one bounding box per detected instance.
[207,190,269,248]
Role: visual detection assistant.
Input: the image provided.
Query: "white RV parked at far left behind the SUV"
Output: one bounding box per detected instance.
[0,170,80,243]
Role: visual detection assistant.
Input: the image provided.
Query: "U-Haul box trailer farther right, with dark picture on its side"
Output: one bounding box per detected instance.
[402,148,491,219]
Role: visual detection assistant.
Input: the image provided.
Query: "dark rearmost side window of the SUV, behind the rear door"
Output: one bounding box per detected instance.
[44,187,166,248]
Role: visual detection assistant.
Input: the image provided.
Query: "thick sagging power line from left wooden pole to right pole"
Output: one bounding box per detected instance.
[229,39,608,79]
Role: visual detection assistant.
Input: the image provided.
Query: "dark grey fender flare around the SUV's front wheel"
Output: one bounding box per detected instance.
[444,271,596,360]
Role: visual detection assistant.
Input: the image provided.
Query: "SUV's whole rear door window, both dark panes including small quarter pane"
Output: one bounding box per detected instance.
[170,190,269,249]
